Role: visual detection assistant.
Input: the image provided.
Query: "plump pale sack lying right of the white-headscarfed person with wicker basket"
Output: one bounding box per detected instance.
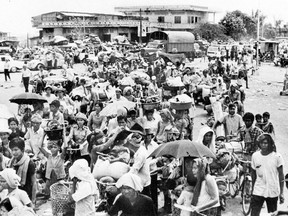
[93,158,130,180]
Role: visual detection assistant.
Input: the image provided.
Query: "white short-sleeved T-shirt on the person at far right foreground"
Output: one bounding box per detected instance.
[251,151,284,198]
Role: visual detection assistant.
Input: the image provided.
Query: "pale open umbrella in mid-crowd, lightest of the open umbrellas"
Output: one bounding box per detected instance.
[99,101,136,116]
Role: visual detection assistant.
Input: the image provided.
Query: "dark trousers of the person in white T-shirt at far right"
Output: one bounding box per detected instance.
[251,195,278,216]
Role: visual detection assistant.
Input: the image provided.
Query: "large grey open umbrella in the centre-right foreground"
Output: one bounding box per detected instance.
[149,140,215,158]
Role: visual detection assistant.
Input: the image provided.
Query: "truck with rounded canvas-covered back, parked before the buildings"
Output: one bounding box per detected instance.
[141,31,195,58]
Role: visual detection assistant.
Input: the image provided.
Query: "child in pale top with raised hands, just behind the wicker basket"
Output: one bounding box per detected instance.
[40,140,66,198]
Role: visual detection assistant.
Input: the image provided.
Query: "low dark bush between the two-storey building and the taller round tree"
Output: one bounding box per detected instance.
[192,23,228,42]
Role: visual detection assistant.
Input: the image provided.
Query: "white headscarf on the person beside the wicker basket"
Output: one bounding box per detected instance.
[69,159,98,194]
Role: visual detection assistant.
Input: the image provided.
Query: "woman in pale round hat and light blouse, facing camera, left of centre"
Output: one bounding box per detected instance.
[69,113,90,164]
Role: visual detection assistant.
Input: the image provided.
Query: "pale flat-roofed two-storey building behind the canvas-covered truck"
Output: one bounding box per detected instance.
[115,5,216,32]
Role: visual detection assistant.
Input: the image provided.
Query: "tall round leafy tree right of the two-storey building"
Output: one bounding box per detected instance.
[220,10,257,40]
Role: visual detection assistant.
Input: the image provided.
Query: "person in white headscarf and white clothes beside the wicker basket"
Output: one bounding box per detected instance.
[69,159,99,216]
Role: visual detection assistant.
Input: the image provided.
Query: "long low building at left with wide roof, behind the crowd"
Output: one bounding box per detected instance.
[32,11,148,41]
